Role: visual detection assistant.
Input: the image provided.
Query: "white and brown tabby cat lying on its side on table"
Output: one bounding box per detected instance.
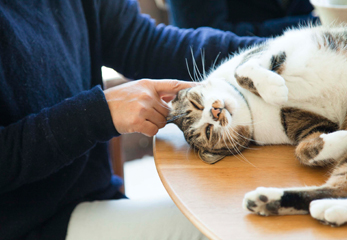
[168,26,347,226]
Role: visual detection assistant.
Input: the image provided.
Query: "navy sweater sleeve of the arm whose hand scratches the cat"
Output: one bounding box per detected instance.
[0,87,118,193]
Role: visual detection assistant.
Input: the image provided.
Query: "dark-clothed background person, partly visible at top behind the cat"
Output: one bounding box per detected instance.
[167,0,319,37]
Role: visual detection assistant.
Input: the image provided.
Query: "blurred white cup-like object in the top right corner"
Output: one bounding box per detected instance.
[310,0,347,26]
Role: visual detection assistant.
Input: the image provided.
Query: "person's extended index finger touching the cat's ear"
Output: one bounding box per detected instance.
[153,80,199,96]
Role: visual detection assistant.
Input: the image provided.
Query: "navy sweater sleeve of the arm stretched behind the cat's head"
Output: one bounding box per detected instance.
[100,0,263,80]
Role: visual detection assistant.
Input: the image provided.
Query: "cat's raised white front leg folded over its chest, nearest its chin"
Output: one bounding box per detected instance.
[235,51,288,105]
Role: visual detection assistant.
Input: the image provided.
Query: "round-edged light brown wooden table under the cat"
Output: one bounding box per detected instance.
[154,124,347,240]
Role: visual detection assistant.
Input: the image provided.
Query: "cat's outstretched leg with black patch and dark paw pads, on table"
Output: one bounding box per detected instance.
[243,154,347,216]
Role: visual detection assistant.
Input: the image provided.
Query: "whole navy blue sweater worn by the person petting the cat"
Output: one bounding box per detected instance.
[0,0,259,240]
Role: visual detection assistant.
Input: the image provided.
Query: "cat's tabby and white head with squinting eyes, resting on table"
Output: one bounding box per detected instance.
[168,79,253,164]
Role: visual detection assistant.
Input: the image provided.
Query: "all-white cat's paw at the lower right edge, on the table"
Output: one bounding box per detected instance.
[310,199,347,227]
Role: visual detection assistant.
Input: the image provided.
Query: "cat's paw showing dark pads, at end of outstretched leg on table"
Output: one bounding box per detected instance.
[243,187,283,216]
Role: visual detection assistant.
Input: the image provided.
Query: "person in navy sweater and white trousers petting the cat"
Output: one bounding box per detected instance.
[0,0,263,240]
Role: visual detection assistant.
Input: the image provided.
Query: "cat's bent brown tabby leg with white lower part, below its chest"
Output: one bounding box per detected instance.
[281,107,347,166]
